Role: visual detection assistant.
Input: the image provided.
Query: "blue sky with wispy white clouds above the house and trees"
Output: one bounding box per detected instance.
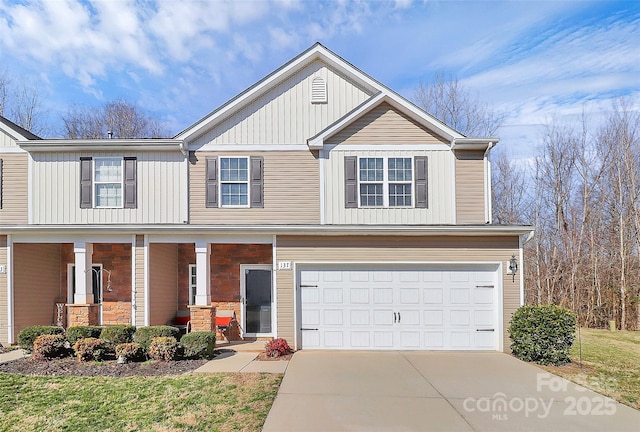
[0,0,640,155]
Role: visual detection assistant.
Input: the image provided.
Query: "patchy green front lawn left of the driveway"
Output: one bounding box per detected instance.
[0,374,282,432]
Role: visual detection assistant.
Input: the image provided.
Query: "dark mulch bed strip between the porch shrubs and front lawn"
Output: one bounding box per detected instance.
[0,357,207,377]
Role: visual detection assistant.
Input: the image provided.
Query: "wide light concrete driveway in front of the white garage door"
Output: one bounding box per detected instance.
[263,351,640,432]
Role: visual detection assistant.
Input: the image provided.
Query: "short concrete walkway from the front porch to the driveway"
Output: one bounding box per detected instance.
[193,342,289,373]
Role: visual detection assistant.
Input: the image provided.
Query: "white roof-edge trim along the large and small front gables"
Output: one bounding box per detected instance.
[175,43,464,145]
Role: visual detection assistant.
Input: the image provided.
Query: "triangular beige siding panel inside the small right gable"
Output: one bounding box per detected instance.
[325,102,449,145]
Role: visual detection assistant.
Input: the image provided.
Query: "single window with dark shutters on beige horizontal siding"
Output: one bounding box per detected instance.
[205,156,264,208]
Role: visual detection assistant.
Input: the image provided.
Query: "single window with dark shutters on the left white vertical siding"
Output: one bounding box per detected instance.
[80,157,138,208]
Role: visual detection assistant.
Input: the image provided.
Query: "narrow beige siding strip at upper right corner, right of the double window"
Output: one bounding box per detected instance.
[456,151,487,224]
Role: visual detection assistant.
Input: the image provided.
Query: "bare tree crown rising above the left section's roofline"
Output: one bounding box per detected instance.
[62,100,168,139]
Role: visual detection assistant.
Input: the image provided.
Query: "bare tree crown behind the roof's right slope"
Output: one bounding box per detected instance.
[413,72,504,137]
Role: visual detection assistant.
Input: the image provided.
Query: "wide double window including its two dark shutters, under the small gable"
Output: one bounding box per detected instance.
[345,156,428,208]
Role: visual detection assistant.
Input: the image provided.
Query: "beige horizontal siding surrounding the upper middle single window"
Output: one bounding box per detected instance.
[189,151,320,224]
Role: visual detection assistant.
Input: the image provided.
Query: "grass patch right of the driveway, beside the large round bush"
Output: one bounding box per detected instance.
[545,329,640,409]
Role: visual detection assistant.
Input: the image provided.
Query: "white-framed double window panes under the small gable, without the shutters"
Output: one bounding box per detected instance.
[358,158,413,207]
